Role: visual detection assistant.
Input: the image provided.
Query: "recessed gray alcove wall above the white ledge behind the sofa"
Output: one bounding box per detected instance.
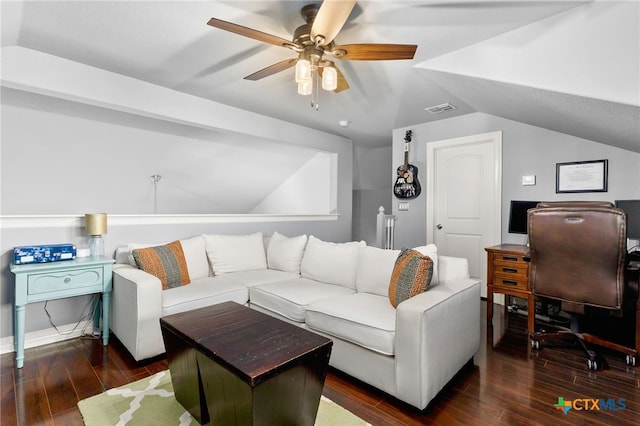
[0,88,338,215]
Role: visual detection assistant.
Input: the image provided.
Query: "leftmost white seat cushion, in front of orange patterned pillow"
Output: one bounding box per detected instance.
[162,275,249,316]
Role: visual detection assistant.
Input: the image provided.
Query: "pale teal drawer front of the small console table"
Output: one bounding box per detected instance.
[27,268,103,294]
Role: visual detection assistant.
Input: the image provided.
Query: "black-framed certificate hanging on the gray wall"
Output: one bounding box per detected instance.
[556,160,609,193]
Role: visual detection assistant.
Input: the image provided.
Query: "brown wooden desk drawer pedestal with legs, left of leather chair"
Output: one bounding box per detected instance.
[485,244,535,334]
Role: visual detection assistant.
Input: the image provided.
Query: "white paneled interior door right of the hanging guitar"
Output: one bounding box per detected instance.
[427,132,502,297]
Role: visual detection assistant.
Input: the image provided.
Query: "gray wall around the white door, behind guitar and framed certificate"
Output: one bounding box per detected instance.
[393,113,640,247]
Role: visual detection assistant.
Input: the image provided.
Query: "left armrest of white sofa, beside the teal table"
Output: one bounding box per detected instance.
[111,265,165,361]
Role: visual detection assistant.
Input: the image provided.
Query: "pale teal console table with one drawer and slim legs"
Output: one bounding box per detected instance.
[10,257,114,368]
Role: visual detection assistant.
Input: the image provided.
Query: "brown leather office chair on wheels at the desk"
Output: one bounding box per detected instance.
[528,201,640,370]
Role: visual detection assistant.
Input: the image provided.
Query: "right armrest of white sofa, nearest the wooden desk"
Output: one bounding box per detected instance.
[395,278,481,408]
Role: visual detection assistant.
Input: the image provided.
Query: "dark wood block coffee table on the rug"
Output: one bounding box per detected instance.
[160,302,333,425]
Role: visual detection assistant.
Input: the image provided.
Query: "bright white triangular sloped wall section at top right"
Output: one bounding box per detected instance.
[420,1,640,106]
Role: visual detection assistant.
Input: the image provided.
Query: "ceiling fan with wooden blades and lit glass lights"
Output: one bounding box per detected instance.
[207,0,418,104]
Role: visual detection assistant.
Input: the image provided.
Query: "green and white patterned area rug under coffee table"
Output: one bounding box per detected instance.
[78,370,368,426]
